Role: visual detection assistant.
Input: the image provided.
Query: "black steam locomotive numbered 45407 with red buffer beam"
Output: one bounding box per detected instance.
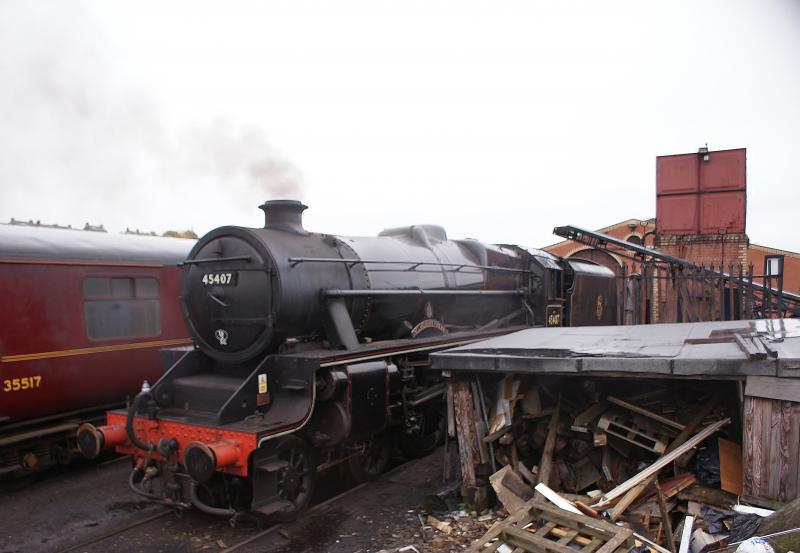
[78,200,616,519]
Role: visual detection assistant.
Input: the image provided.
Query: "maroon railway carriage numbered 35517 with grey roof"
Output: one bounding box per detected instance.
[0,225,194,476]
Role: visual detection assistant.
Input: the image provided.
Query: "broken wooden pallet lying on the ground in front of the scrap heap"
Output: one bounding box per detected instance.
[467,499,634,553]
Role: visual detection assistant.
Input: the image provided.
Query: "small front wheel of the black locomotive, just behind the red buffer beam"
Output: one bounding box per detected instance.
[275,436,316,521]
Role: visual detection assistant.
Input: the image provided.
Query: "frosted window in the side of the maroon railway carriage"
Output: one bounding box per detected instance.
[83,277,161,340]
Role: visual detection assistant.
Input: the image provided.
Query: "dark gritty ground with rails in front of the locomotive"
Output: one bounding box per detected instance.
[0,449,496,553]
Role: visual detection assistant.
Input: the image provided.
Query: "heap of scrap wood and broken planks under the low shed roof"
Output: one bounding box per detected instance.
[451,375,788,553]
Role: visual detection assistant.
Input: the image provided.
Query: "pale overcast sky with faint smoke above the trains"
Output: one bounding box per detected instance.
[0,0,800,251]
